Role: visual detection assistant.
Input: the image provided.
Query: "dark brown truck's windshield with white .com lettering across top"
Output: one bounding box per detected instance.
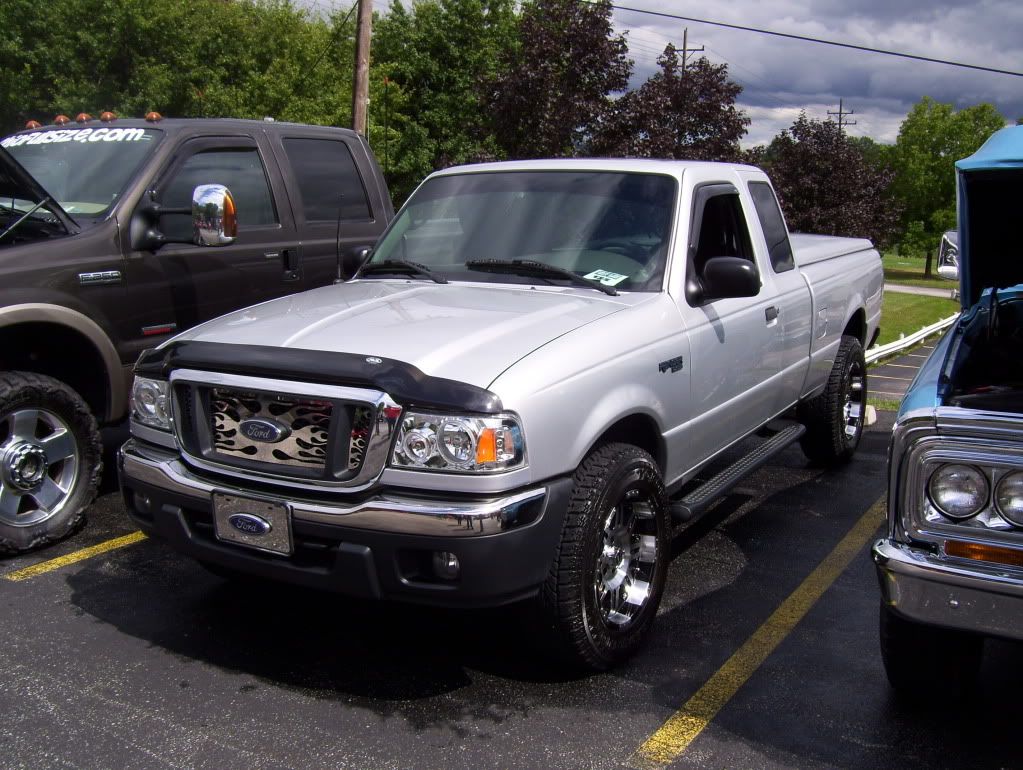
[0,127,163,219]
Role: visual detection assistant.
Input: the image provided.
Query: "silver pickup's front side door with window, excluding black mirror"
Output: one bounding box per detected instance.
[675,169,779,467]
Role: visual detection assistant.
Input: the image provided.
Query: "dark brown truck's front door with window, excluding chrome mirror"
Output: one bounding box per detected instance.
[120,136,300,357]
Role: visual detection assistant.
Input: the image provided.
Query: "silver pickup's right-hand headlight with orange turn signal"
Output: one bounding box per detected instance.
[391,412,526,473]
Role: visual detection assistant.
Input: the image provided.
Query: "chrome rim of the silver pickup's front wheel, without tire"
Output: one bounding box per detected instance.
[593,489,658,628]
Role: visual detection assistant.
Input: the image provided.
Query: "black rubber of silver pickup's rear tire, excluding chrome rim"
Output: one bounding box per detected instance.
[799,334,868,467]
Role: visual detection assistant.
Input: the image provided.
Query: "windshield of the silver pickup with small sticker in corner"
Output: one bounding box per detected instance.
[369,171,676,291]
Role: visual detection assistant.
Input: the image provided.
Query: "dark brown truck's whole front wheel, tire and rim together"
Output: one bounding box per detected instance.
[0,371,103,553]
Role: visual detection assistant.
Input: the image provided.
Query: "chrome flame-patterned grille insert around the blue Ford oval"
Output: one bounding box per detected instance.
[210,388,331,468]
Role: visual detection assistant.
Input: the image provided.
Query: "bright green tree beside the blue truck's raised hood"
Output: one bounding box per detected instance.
[891,96,1006,273]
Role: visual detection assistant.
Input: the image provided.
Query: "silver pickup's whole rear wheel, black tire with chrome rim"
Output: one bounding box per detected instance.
[799,334,866,466]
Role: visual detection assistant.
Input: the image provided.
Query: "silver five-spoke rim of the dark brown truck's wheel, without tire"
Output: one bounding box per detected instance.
[0,408,79,527]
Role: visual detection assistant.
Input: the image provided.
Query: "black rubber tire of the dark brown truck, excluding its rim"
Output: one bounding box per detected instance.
[0,371,103,554]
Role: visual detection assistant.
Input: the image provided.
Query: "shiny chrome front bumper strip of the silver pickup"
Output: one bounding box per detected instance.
[120,440,547,537]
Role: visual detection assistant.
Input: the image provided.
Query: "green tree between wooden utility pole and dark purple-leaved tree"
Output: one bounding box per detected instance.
[371,0,516,200]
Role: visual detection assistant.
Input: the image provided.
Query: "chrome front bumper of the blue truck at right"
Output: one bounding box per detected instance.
[872,540,1023,639]
